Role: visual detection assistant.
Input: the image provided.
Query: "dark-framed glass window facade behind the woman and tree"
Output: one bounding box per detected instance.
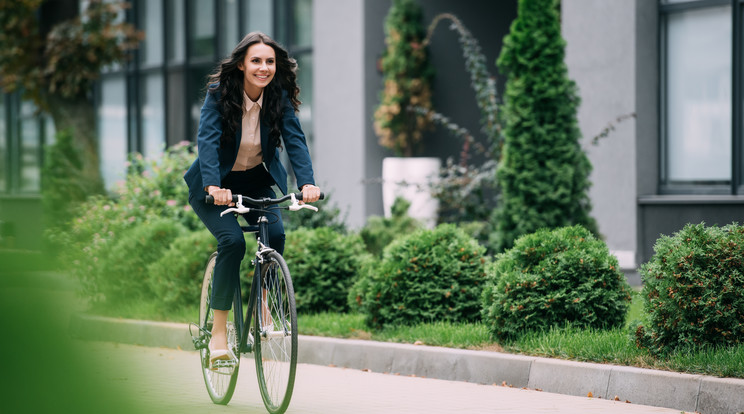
[0,0,312,194]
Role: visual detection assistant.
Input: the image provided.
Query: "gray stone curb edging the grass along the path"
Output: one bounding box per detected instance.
[70,315,744,414]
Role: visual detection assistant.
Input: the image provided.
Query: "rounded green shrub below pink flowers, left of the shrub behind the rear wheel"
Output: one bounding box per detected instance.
[97,218,185,304]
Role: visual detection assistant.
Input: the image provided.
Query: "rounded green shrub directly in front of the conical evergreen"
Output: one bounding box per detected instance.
[482,226,631,339]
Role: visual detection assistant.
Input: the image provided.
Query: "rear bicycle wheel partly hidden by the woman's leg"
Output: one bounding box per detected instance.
[199,252,240,405]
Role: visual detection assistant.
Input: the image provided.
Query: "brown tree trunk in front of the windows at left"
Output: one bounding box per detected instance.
[48,96,105,195]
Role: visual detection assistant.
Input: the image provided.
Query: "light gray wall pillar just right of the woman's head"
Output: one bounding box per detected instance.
[312,0,368,225]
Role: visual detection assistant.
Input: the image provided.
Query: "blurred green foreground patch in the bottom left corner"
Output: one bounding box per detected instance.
[0,250,146,413]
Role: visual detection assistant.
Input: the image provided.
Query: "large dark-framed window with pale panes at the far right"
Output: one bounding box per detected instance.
[660,0,744,194]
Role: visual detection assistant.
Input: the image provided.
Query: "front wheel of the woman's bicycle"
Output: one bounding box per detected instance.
[254,252,297,414]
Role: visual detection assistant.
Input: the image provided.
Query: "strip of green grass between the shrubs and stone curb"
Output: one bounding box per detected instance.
[91,293,744,378]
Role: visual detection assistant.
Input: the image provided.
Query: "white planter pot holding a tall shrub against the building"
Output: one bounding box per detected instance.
[382,157,442,228]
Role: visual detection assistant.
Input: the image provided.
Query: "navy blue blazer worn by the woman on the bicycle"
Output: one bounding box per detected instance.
[183,85,315,199]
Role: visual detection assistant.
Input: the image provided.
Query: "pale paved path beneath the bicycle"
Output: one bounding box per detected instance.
[79,342,692,414]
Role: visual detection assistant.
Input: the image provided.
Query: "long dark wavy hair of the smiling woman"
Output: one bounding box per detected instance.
[207,32,301,147]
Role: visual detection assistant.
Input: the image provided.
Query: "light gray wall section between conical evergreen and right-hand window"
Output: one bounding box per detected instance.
[561,0,640,268]
